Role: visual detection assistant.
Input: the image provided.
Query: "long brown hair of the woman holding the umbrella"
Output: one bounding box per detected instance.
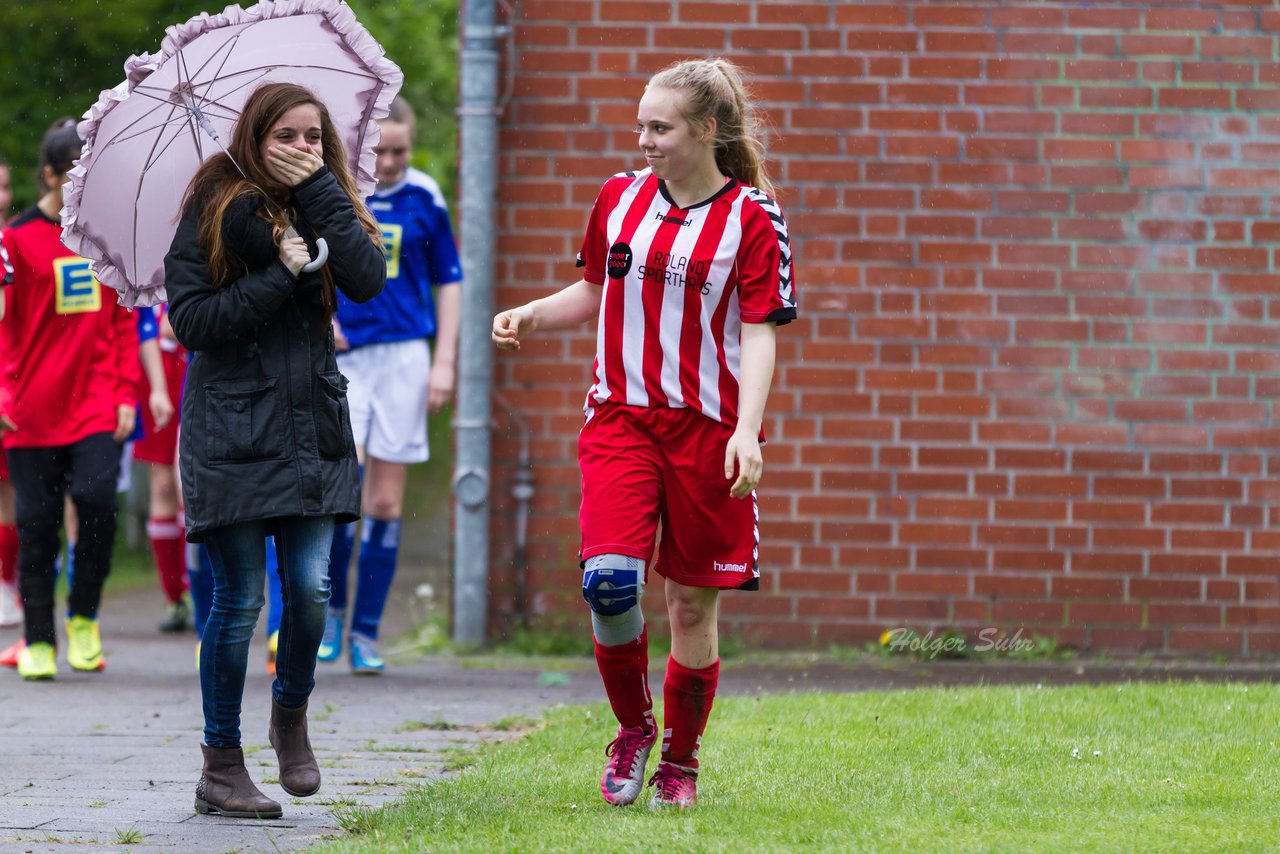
[183,83,381,314]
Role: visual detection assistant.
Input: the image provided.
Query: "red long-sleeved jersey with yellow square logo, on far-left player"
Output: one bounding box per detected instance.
[0,207,142,448]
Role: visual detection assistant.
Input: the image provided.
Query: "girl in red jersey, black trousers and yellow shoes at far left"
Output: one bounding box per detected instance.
[0,119,141,680]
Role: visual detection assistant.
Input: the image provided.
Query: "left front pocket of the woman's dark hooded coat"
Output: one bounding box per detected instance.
[205,376,285,462]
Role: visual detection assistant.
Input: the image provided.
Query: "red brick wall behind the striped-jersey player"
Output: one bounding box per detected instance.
[483,0,1280,654]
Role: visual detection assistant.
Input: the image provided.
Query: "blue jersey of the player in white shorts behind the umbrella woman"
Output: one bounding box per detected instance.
[338,169,462,348]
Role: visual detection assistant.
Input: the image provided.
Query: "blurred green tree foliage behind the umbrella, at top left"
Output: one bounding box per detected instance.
[0,0,458,214]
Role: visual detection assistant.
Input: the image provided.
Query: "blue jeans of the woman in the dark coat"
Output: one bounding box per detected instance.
[200,516,333,748]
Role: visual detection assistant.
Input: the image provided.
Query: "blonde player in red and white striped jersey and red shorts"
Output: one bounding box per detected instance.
[493,59,796,809]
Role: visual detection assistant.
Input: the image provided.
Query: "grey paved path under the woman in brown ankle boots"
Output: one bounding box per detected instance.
[0,571,603,853]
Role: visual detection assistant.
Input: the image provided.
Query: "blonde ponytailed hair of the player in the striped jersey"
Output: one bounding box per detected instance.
[649,58,774,196]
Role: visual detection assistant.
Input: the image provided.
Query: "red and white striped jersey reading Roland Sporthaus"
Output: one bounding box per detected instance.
[577,169,796,426]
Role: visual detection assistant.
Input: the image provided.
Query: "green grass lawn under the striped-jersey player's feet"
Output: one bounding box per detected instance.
[307,682,1280,854]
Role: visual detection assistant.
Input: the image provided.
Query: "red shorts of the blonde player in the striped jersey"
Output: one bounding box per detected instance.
[577,403,760,590]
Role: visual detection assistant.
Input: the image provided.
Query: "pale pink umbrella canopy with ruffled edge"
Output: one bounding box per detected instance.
[63,0,403,307]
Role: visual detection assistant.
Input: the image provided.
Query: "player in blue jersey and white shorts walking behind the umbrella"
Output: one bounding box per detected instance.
[320,97,462,675]
